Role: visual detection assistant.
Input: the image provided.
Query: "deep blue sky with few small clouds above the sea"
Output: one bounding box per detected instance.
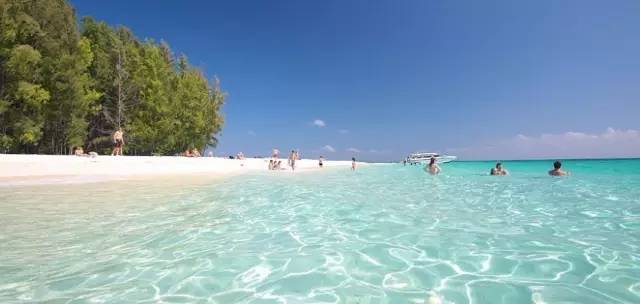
[71,0,640,161]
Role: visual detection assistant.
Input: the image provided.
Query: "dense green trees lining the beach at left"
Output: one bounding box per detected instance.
[0,0,225,155]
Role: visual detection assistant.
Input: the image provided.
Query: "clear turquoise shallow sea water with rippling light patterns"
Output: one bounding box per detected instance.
[0,160,640,303]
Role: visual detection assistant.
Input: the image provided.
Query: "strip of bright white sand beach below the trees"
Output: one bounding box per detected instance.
[0,154,361,181]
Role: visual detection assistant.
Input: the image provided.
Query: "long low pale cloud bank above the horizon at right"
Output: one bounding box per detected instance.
[447,128,640,159]
